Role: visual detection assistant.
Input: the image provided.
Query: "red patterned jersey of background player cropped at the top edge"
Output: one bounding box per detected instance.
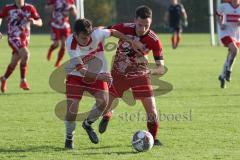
[47,0,75,29]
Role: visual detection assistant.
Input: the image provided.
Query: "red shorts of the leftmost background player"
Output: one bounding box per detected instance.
[8,37,29,53]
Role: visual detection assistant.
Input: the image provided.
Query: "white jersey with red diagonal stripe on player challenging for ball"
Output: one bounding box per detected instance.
[66,29,112,77]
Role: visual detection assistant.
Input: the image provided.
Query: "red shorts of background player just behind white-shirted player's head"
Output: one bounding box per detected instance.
[51,27,71,41]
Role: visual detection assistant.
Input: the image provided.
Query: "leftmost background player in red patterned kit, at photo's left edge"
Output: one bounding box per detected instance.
[0,0,42,93]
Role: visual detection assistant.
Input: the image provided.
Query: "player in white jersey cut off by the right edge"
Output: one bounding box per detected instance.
[216,0,240,88]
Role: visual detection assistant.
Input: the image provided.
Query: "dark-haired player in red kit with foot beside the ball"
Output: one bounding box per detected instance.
[99,6,164,145]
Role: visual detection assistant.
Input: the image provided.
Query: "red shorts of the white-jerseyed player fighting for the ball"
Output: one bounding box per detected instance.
[66,75,108,100]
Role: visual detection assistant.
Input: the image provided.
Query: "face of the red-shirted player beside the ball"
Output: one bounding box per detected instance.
[135,17,152,36]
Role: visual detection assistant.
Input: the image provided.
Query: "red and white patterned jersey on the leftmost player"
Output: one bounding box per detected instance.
[0,3,40,39]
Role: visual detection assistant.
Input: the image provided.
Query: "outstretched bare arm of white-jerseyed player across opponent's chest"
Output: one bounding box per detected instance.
[112,29,144,54]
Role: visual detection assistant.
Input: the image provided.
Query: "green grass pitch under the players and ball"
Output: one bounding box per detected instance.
[0,34,240,160]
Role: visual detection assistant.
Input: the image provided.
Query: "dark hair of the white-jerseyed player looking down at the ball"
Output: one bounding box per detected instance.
[73,18,92,34]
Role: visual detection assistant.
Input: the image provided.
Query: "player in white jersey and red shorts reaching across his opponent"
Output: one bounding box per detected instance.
[65,19,143,149]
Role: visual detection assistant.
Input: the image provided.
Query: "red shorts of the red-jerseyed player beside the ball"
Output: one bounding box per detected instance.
[109,71,154,99]
